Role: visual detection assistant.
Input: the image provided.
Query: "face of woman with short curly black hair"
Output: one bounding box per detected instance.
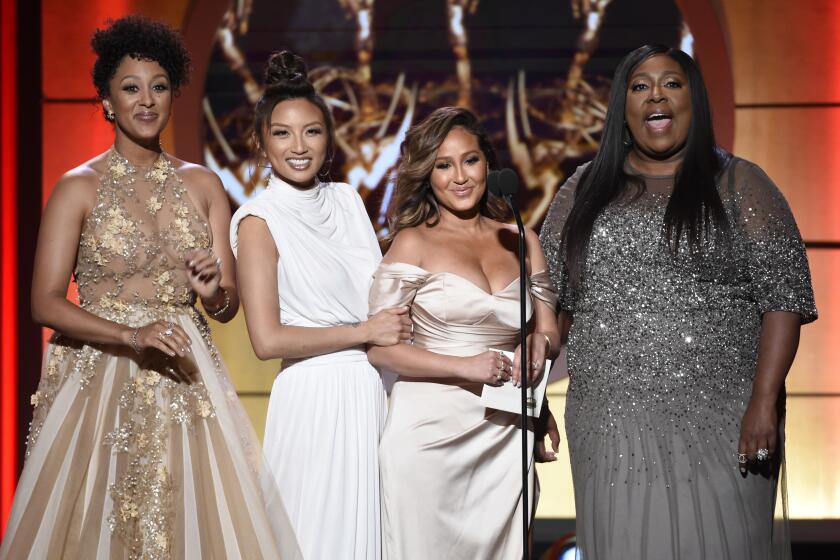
[102,56,172,143]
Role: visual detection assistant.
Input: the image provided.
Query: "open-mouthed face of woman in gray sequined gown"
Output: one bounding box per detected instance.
[624,55,691,161]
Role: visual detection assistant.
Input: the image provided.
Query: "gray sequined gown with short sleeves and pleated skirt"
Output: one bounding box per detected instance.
[541,158,817,560]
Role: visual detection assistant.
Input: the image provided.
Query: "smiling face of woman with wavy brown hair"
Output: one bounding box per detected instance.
[429,127,487,215]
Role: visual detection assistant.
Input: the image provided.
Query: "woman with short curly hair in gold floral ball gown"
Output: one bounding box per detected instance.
[0,16,299,559]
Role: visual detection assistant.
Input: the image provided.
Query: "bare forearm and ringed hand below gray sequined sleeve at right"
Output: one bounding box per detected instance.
[738,311,801,472]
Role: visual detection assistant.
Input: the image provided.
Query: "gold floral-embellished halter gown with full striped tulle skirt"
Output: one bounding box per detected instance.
[0,150,300,560]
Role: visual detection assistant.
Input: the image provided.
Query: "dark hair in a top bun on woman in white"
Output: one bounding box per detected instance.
[254,50,335,176]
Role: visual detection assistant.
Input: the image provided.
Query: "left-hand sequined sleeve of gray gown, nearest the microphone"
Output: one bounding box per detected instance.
[540,163,589,311]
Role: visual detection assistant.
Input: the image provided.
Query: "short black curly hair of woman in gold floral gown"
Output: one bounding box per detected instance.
[90,15,190,114]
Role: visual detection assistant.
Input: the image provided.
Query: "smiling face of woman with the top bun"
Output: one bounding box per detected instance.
[263,99,329,188]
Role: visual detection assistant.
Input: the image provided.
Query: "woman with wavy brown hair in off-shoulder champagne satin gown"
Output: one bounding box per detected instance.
[368,107,560,559]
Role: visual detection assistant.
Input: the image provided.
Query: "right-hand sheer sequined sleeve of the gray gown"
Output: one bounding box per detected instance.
[732,160,817,323]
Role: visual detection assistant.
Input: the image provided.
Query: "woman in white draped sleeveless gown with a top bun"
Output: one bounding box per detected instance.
[230,51,410,559]
